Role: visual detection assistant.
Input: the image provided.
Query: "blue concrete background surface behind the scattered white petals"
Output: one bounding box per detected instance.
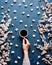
[0,0,52,65]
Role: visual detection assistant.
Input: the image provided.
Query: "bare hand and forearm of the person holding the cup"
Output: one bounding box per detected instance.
[23,38,30,60]
